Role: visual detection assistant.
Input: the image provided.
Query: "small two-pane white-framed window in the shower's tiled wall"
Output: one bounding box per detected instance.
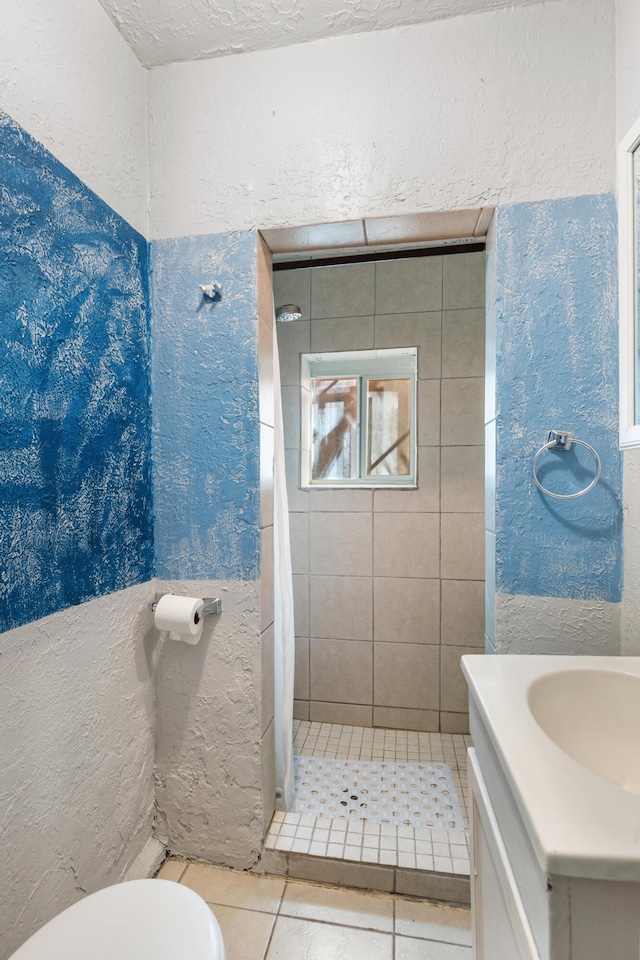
[301,347,417,487]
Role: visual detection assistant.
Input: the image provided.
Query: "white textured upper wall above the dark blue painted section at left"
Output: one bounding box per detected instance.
[0,0,147,235]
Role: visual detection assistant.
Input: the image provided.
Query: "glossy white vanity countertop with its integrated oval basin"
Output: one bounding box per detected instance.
[462,655,640,882]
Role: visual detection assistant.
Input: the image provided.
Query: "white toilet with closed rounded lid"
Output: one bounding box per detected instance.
[10,880,225,960]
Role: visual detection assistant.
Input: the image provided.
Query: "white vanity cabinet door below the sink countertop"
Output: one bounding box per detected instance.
[469,750,540,960]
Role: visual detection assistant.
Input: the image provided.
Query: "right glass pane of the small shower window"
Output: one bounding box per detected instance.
[367,379,411,477]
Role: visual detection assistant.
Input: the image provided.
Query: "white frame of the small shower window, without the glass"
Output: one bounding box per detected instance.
[300,347,418,490]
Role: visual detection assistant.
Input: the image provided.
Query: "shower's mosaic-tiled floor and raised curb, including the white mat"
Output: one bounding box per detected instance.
[264,720,471,888]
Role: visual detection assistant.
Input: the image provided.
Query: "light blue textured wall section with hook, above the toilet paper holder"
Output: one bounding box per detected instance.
[151,231,260,580]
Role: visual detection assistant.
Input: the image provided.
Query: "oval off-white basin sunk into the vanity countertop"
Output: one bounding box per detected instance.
[528,670,640,796]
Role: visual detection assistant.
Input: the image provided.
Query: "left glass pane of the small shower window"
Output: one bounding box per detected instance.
[311,377,358,480]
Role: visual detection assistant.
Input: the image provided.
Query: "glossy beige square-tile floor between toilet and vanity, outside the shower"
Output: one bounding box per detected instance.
[158,859,471,960]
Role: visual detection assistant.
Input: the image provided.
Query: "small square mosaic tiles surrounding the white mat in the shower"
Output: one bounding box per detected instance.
[265,720,471,877]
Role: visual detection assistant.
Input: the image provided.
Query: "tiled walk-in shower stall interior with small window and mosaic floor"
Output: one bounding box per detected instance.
[263,246,485,902]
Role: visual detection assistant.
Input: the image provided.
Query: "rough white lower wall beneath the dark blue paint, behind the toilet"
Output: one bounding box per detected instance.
[0,584,155,958]
